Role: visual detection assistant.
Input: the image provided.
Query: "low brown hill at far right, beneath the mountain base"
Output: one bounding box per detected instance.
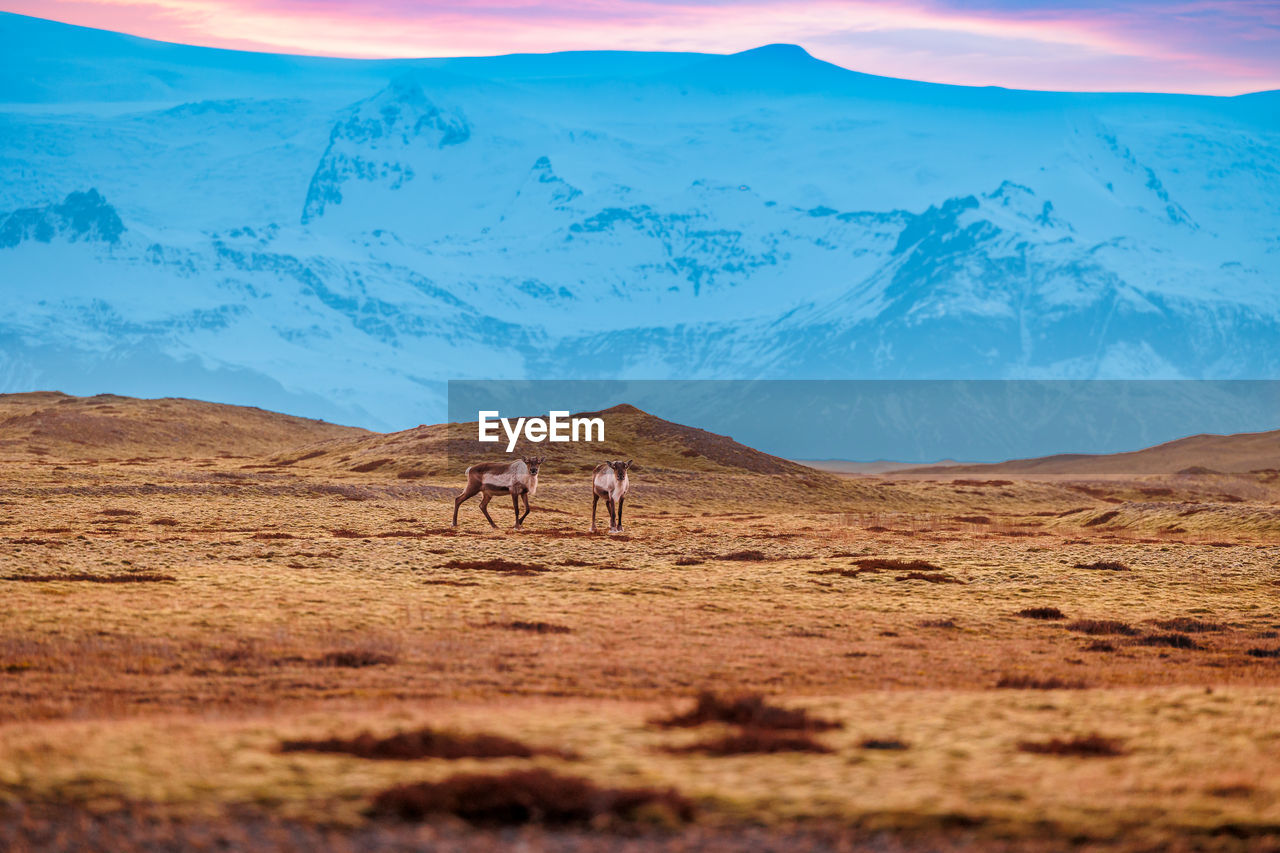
[887,429,1280,476]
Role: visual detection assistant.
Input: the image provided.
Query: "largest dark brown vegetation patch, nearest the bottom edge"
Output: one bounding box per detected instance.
[369,768,694,829]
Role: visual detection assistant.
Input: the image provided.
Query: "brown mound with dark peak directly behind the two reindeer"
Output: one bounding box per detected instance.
[273,405,836,484]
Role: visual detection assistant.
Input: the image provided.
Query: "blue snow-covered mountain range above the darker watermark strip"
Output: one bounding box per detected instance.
[0,14,1280,428]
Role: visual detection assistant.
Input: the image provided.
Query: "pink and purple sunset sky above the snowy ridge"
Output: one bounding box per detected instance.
[0,0,1280,95]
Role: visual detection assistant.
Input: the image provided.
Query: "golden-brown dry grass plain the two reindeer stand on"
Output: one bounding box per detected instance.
[0,394,1280,850]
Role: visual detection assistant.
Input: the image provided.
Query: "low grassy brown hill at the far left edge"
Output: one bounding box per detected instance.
[0,391,369,459]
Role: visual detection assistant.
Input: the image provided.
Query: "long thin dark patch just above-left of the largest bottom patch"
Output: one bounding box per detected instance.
[280,729,561,761]
